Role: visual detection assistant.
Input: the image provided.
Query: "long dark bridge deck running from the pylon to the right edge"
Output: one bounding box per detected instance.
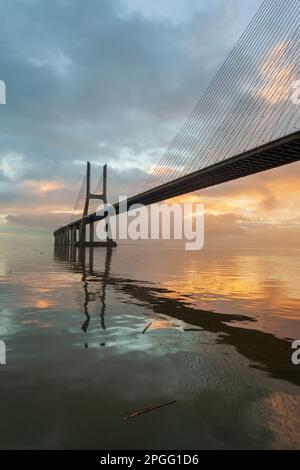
[54,131,300,235]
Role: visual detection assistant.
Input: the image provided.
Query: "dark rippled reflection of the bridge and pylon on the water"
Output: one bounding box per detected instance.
[55,246,300,385]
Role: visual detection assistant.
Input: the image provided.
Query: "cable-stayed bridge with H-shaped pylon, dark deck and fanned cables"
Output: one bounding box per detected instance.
[54,0,300,246]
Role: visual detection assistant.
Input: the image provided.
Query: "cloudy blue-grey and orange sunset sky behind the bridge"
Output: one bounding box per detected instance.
[0,0,300,247]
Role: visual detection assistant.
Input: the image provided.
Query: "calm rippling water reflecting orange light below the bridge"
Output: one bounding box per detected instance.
[0,244,300,449]
